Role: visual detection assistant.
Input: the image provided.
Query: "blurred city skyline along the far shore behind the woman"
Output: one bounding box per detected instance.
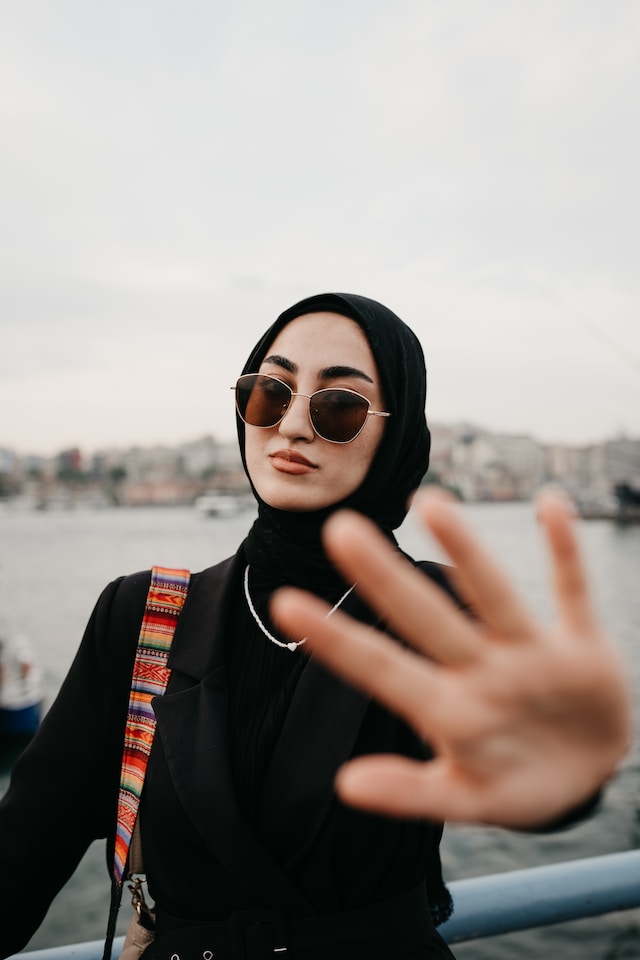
[5,416,640,519]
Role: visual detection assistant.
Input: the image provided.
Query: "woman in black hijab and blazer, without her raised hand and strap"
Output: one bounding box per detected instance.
[0,294,632,960]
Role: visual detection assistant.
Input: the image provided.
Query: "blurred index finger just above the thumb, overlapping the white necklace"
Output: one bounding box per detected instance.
[271,588,443,739]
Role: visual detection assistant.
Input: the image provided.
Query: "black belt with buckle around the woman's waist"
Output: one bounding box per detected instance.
[141,885,439,960]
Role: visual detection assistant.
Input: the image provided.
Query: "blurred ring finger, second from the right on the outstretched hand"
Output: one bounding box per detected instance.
[414,491,536,641]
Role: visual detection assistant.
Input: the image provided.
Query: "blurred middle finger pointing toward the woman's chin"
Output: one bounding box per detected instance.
[323,511,479,666]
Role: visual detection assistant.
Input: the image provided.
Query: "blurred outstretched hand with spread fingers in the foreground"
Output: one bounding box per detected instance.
[273,493,631,829]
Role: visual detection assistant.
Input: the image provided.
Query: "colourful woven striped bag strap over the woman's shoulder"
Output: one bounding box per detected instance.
[113,567,190,887]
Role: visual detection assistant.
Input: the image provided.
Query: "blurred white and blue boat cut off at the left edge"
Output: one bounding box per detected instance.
[0,632,42,745]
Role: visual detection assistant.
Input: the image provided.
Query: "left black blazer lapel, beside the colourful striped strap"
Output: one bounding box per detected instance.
[153,557,311,912]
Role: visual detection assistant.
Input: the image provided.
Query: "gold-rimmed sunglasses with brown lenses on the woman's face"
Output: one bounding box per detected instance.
[231,373,391,443]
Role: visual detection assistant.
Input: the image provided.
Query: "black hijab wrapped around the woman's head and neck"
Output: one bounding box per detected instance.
[237,293,430,592]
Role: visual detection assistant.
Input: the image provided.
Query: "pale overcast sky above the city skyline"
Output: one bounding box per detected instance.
[0,0,640,454]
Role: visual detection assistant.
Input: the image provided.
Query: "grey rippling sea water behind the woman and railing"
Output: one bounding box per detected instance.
[0,503,640,960]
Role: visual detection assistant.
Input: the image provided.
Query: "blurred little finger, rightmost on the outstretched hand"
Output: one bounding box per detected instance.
[538,493,598,637]
